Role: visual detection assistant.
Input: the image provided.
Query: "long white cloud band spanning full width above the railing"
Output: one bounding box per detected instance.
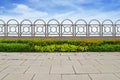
[0,3,120,21]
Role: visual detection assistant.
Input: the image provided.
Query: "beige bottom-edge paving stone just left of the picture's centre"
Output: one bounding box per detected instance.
[33,74,61,80]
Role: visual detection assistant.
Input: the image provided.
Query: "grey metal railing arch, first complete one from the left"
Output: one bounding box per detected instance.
[7,19,19,36]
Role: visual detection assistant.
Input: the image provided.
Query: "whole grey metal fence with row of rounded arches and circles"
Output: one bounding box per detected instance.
[0,19,120,37]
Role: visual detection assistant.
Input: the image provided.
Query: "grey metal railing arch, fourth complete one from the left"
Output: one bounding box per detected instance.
[47,19,60,36]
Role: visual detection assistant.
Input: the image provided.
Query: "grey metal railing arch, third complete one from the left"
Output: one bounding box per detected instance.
[34,19,46,36]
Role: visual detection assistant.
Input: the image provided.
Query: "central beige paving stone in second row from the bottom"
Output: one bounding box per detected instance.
[50,65,75,74]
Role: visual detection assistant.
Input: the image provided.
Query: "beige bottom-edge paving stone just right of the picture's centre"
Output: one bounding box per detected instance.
[62,75,91,80]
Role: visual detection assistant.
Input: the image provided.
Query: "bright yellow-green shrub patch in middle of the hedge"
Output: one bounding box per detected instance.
[35,44,88,52]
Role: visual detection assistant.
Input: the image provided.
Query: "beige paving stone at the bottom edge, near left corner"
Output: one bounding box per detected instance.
[3,74,34,80]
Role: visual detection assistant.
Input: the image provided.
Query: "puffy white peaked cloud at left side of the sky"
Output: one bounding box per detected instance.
[1,4,48,20]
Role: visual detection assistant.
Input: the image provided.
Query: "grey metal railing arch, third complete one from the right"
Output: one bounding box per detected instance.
[75,19,87,36]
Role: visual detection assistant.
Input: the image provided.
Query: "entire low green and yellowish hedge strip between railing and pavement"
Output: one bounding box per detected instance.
[0,39,120,52]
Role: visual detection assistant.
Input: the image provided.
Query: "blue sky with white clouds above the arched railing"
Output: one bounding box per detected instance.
[0,0,120,20]
